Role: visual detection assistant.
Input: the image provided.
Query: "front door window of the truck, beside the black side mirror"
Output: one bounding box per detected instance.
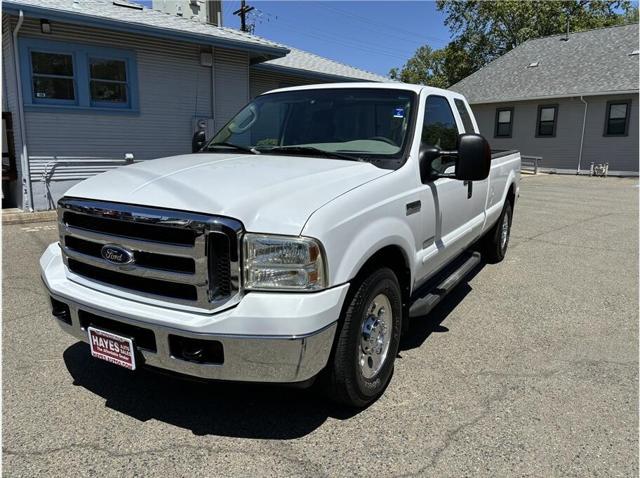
[422,95,459,173]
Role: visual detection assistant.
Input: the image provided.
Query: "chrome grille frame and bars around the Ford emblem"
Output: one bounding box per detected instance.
[58,197,243,311]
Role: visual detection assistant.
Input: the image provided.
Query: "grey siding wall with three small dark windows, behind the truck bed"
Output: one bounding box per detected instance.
[471,94,638,173]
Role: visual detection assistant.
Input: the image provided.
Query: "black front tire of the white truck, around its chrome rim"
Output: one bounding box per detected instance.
[325,268,402,408]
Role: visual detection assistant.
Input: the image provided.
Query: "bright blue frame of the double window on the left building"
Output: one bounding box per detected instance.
[19,37,139,114]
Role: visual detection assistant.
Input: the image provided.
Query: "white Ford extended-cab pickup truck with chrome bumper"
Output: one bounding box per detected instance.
[40,83,520,407]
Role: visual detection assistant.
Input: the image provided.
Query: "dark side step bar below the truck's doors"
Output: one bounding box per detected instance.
[409,252,481,318]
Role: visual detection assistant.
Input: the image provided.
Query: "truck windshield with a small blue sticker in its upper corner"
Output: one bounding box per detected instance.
[204,88,415,167]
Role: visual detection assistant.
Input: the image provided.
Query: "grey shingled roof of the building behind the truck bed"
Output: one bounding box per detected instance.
[451,23,638,104]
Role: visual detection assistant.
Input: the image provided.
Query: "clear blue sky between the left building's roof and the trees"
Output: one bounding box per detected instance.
[222,0,449,75]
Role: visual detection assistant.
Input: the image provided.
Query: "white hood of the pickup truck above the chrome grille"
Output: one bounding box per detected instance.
[65,153,391,235]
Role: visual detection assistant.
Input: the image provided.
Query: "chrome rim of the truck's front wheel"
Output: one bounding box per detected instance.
[358,294,393,378]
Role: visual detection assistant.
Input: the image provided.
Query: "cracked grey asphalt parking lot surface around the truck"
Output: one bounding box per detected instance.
[2,176,638,477]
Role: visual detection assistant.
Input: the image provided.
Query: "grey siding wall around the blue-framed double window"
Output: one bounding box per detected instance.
[2,16,254,209]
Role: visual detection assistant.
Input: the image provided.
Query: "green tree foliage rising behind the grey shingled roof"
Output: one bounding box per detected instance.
[389,0,638,88]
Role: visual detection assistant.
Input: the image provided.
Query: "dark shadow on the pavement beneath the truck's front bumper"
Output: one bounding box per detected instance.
[64,342,358,440]
